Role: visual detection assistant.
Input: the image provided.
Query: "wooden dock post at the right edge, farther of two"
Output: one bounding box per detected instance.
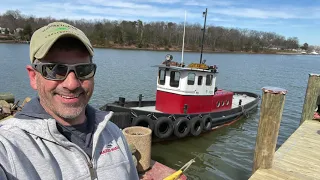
[300,74,320,125]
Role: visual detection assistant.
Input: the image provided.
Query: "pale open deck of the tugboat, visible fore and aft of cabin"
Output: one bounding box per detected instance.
[132,94,256,113]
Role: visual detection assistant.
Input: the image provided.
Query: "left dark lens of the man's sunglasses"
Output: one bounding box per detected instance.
[42,64,68,80]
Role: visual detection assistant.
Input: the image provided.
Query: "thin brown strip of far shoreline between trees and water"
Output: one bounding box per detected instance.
[0,40,309,55]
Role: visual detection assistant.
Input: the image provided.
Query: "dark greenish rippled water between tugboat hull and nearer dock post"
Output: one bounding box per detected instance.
[152,111,258,179]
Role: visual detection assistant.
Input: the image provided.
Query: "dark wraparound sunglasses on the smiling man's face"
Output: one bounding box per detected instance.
[32,63,97,81]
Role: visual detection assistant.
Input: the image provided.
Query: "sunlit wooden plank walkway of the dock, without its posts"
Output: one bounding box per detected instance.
[250,120,320,180]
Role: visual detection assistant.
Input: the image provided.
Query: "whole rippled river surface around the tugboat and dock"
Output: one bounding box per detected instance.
[0,44,320,180]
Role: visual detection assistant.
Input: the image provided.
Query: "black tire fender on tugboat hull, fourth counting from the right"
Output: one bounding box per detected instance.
[154,117,173,139]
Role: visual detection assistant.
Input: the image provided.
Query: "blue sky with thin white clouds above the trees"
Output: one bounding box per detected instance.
[0,0,320,45]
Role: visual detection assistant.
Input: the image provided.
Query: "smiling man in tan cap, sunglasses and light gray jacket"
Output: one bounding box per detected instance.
[0,22,139,180]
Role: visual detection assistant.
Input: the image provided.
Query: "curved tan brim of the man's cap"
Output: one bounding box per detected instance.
[34,33,93,59]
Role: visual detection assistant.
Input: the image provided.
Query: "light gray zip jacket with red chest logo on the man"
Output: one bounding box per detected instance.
[0,99,139,180]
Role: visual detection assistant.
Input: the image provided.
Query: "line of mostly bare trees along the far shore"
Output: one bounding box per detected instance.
[0,10,308,52]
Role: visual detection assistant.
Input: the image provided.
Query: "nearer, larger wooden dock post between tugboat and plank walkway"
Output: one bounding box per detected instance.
[252,87,287,174]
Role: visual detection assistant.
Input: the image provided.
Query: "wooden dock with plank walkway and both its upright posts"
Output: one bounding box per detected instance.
[249,74,320,180]
